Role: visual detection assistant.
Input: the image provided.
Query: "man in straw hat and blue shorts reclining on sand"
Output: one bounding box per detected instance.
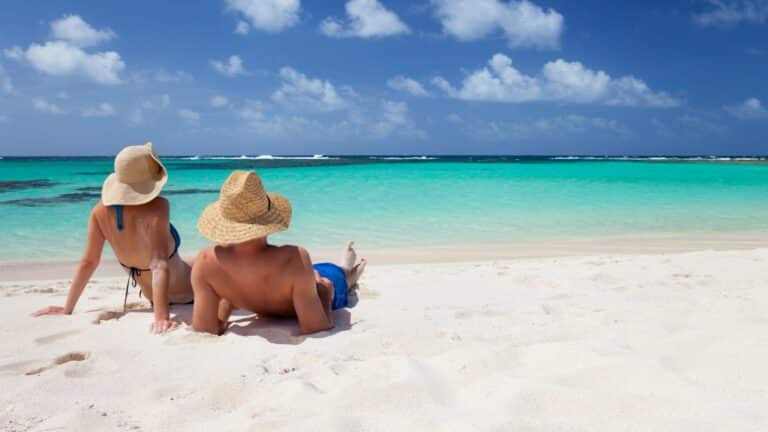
[192,171,365,334]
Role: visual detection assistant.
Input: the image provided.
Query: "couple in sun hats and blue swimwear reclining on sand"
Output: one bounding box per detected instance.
[33,144,365,335]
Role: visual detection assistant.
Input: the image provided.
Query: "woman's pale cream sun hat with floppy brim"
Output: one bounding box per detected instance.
[101,143,168,206]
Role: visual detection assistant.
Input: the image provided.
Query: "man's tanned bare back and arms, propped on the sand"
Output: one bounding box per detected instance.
[192,238,333,334]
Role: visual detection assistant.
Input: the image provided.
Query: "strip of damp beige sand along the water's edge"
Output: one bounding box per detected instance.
[0,231,768,281]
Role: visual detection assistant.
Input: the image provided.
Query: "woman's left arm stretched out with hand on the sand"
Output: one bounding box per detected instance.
[32,207,104,317]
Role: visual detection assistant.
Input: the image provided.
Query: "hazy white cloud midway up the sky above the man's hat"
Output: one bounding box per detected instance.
[272,67,349,112]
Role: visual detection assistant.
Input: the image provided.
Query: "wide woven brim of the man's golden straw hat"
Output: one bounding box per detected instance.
[197,192,291,244]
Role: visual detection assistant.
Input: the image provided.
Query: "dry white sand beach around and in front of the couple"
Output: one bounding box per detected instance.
[0,250,768,432]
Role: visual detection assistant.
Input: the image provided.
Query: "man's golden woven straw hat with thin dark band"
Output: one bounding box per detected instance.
[197,171,291,244]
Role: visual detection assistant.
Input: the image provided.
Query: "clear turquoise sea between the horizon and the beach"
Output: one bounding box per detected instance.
[0,157,768,261]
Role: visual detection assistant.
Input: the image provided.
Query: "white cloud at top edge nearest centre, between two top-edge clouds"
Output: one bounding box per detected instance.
[320,0,410,38]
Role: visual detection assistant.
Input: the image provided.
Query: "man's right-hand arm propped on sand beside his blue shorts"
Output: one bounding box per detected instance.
[293,248,333,334]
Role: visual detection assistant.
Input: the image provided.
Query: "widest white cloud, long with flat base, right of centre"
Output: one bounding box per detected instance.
[432,54,681,108]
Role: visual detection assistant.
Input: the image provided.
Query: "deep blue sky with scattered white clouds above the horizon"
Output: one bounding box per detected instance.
[0,0,768,155]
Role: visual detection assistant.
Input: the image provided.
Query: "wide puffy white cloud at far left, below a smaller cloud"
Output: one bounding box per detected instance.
[5,41,125,84]
